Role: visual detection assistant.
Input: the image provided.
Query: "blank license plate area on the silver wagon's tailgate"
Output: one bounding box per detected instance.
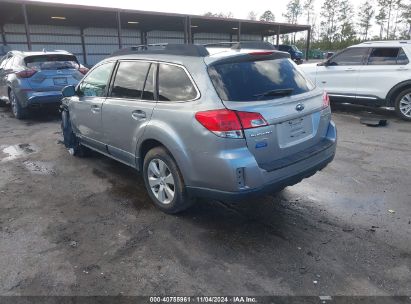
[278,116,313,147]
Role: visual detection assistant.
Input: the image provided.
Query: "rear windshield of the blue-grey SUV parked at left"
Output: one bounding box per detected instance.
[24,55,80,70]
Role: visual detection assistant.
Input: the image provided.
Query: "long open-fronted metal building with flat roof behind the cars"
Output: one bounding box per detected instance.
[0,0,311,66]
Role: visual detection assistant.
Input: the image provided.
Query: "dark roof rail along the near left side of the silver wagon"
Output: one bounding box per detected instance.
[111,43,209,57]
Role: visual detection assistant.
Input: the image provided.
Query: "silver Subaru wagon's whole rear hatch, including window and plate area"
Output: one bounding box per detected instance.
[209,54,330,171]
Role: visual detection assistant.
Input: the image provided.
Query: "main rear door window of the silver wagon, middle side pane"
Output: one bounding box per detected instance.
[111,61,150,99]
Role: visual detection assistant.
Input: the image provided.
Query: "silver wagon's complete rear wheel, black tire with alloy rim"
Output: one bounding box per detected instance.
[143,147,193,214]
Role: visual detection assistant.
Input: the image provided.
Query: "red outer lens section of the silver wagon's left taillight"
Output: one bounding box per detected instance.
[195,109,241,132]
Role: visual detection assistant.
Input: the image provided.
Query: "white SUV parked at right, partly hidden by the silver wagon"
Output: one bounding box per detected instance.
[300,41,411,121]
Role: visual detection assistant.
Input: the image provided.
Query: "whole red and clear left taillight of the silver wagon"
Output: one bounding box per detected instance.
[195,109,268,138]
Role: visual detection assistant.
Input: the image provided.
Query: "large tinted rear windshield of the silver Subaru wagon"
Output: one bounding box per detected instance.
[209,58,314,101]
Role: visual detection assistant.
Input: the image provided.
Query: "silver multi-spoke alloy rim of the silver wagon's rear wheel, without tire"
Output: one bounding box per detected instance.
[147,158,175,205]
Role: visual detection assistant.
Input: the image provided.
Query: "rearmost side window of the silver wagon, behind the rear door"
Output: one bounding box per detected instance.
[158,64,197,101]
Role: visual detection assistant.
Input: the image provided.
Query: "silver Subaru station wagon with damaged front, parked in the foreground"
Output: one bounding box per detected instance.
[62,44,336,213]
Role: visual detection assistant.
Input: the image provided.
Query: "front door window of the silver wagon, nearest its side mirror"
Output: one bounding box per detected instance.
[78,62,114,97]
